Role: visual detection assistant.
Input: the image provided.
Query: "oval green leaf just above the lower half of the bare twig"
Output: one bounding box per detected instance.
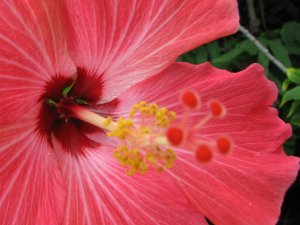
[268,39,292,67]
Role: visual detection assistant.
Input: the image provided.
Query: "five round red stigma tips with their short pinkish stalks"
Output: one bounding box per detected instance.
[166,90,233,162]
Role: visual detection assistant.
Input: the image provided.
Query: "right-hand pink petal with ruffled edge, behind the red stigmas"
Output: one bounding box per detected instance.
[116,63,299,225]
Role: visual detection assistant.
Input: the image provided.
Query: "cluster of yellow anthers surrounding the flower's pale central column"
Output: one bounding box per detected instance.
[108,101,176,175]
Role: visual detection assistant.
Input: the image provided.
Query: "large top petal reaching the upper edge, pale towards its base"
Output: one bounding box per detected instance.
[66,0,238,102]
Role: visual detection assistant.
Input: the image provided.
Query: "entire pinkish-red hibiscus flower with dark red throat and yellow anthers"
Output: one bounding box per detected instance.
[0,0,299,225]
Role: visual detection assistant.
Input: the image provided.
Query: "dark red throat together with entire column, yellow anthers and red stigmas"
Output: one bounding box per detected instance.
[39,70,233,175]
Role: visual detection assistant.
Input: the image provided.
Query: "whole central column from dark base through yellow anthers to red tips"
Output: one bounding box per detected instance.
[54,87,233,175]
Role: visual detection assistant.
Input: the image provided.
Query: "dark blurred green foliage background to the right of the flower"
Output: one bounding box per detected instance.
[178,0,300,225]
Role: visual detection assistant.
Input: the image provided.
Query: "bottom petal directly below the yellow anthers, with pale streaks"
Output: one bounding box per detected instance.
[51,143,207,225]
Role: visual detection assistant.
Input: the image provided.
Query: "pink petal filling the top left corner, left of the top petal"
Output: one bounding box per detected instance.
[0,0,73,122]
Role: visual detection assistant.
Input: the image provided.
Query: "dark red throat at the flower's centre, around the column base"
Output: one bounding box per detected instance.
[38,68,118,157]
